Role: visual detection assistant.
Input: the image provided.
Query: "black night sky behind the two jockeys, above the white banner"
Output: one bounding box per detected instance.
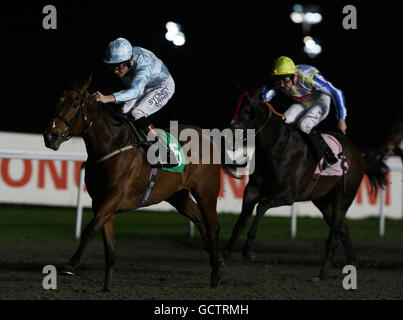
[0,0,402,151]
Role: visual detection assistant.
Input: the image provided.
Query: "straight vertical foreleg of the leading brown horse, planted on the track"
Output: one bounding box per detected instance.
[102,217,116,291]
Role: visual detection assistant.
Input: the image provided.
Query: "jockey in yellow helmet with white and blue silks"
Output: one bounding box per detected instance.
[262,56,347,168]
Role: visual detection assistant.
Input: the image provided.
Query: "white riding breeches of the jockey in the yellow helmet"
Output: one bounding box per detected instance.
[284,94,331,134]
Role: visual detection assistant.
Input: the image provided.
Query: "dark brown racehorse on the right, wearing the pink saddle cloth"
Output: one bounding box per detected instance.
[224,90,387,280]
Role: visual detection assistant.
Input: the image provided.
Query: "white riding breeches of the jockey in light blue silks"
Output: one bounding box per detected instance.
[122,76,175,120]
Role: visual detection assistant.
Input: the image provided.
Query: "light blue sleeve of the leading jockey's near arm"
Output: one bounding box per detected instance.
[113,55,155,103]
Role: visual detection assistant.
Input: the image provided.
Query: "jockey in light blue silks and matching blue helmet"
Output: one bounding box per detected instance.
[93,38,175,167]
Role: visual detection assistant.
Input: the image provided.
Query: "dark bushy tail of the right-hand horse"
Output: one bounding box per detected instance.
[364,151,389,194]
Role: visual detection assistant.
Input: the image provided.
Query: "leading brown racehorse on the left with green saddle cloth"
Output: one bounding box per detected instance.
[44,76,221,291]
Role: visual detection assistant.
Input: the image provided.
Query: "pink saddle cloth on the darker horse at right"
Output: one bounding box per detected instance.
[315,133,348,176]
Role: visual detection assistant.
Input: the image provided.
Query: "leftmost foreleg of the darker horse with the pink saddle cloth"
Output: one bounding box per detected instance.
[223,185,260,259]
